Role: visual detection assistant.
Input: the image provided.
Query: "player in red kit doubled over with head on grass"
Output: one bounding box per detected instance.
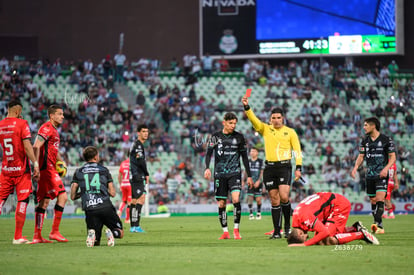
[287,192,379,246]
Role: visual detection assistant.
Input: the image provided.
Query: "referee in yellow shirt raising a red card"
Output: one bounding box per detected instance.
[242,95,302,239]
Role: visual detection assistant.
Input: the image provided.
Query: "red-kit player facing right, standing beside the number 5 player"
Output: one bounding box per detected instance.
[31,105,68,244]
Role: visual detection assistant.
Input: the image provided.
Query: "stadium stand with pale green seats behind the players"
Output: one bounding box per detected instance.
[0,56,414,208]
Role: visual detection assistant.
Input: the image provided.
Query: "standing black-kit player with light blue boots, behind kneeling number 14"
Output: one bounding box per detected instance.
[129,124,149,233]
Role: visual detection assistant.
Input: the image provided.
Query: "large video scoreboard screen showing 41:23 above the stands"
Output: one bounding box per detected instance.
[200,0,404,58]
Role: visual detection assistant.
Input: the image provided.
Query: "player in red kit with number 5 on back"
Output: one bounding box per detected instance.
[0,101,39,244]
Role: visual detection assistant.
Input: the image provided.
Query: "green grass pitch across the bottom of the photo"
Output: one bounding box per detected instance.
[0,215,414,275]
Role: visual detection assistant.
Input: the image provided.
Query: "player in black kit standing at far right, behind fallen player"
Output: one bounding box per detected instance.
[351,117,396,234]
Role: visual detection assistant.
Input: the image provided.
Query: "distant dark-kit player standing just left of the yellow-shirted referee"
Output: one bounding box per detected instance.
[247,147,264,220]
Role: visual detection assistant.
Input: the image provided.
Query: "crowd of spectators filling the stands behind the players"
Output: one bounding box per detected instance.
[0,52,414,207]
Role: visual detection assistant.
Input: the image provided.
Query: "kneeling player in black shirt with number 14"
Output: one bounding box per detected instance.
[70,146,124,247]
